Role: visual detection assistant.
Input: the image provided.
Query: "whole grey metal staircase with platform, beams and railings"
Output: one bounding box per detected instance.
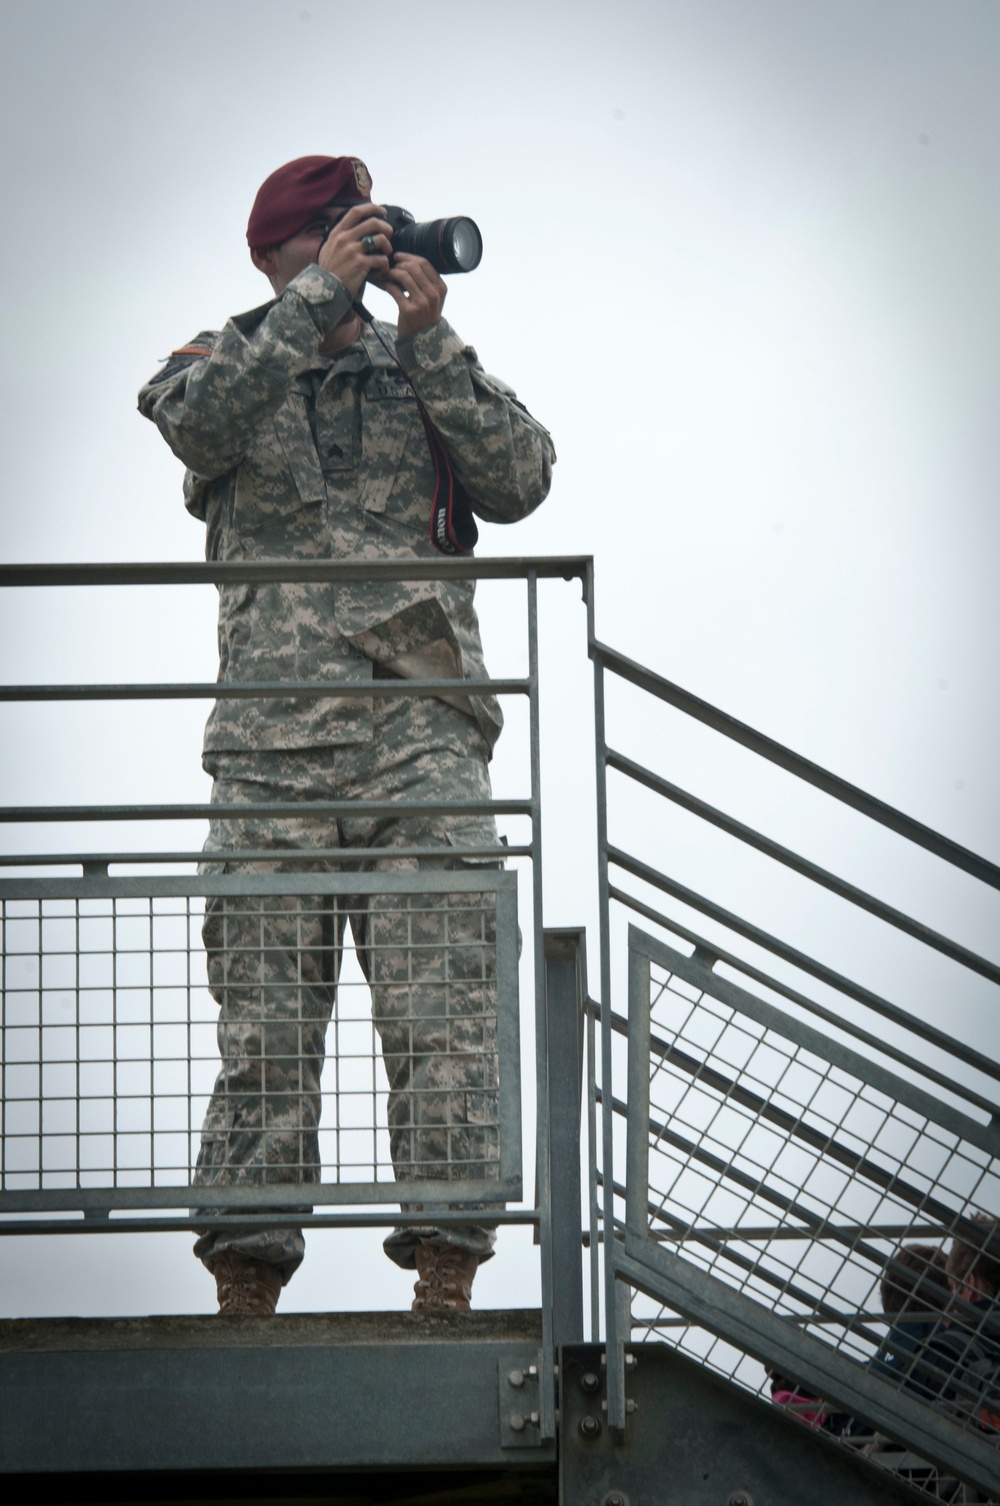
[0,559,1000,1506]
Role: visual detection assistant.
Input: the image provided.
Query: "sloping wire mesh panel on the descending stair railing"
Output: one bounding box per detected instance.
[622,928,1000,1498]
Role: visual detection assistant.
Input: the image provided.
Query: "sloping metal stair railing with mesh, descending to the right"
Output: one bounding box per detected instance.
[589,625,1000,1492]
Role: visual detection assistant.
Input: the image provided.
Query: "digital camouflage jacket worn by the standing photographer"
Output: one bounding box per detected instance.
[139,265,556,751]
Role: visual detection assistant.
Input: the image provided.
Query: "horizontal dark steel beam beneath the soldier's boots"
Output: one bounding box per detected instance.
[0,1312,556,1475]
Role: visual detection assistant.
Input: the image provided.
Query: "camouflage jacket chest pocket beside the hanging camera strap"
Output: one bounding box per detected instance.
[361,367,421,518]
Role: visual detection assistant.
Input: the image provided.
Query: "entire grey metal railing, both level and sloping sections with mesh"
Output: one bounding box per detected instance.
[0,559,1000,1489]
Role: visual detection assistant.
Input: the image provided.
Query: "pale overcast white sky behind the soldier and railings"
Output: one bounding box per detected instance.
[0,0,1000,1312]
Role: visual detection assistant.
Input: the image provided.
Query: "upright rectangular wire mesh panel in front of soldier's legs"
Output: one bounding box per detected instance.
[0,867,521,1227]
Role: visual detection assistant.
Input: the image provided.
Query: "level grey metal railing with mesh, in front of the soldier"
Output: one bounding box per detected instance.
[0,557,590,1438]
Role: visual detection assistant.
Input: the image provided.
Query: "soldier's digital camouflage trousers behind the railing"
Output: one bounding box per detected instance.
[194,697,498,1282]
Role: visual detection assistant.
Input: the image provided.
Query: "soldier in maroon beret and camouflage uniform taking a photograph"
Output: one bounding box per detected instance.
[139,157,554,1313]
